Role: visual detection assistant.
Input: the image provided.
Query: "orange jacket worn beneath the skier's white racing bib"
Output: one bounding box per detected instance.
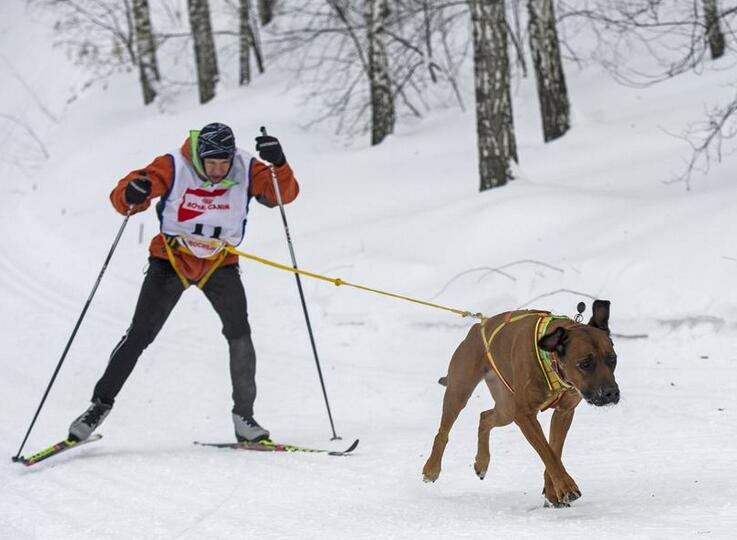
[110,137,299,281]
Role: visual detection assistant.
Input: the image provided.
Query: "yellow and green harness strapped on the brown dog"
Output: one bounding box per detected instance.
[480,311,573,411]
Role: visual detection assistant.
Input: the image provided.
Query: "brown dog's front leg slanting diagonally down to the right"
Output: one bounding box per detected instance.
[514,413,581,506]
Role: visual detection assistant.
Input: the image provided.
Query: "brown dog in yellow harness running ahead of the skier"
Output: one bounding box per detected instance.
[422,300,619,506]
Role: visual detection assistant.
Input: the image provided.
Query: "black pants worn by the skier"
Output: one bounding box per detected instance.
[92,257,256,417]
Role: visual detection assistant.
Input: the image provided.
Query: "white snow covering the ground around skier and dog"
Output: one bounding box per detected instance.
[0,2,737,539]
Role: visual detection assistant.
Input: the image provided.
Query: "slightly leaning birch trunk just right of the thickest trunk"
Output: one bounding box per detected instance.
[527,0,571,142]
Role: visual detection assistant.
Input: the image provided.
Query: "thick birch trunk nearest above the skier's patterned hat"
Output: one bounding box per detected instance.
[187,0,219,103]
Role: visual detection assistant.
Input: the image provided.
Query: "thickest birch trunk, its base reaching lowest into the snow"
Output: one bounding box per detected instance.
[468,0,517,191]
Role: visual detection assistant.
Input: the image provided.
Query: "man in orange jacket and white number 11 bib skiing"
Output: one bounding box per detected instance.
[69,123,299,442]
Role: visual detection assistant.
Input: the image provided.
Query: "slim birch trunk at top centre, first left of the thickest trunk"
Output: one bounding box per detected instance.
[366,0,395,146]
